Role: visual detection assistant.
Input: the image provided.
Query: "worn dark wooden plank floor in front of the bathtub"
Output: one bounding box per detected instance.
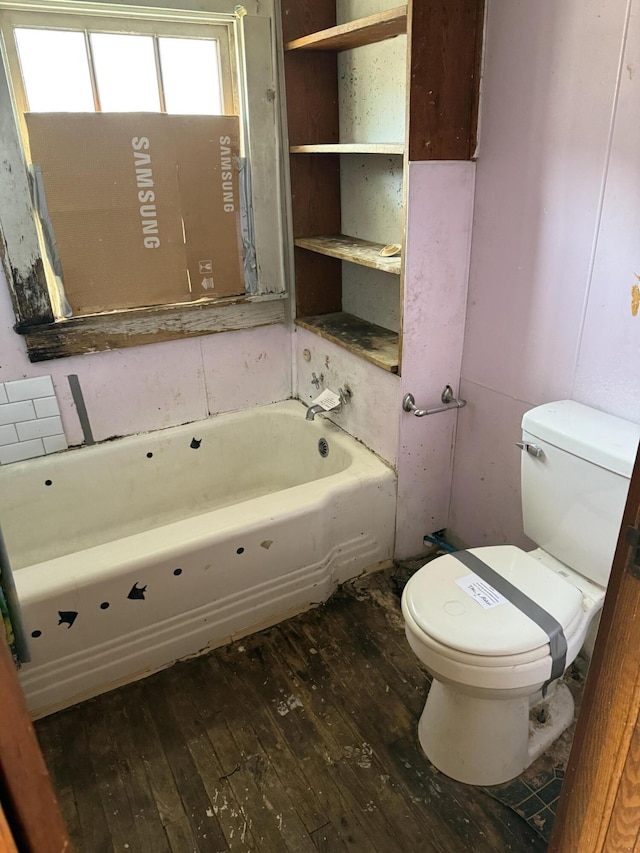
[36,575,546,853]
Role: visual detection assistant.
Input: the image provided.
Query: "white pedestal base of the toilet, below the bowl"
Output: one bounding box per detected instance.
[418,679,574,785]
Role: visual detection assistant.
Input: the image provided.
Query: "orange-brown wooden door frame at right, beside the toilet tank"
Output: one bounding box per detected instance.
[549,453,640,853]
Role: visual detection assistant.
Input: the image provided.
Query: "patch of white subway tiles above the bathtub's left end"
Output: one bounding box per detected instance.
[0,376,68,465]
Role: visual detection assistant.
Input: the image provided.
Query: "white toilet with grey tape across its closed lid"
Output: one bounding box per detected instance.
[402,400,640,785]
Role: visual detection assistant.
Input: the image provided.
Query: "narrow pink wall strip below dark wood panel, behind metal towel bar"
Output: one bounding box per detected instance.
[396,162,475,558]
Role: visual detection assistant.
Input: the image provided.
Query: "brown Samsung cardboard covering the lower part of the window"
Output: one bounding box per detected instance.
[26,113,245,315]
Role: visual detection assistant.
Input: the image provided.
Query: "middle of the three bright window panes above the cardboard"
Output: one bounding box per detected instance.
[91,33,160,113]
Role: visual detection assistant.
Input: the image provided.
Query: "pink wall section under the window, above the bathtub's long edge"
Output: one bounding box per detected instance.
[0,272,291,444]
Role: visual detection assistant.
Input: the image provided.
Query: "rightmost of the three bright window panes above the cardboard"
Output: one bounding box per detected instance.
[158,38,222,115]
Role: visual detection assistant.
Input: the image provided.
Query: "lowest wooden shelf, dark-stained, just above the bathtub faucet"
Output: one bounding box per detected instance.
[296,311,399,373]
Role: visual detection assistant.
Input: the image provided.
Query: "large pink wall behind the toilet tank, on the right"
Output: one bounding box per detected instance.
[449,0,640,546]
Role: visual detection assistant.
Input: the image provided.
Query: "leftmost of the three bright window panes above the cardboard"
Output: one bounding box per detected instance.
[15,28,94,113]
